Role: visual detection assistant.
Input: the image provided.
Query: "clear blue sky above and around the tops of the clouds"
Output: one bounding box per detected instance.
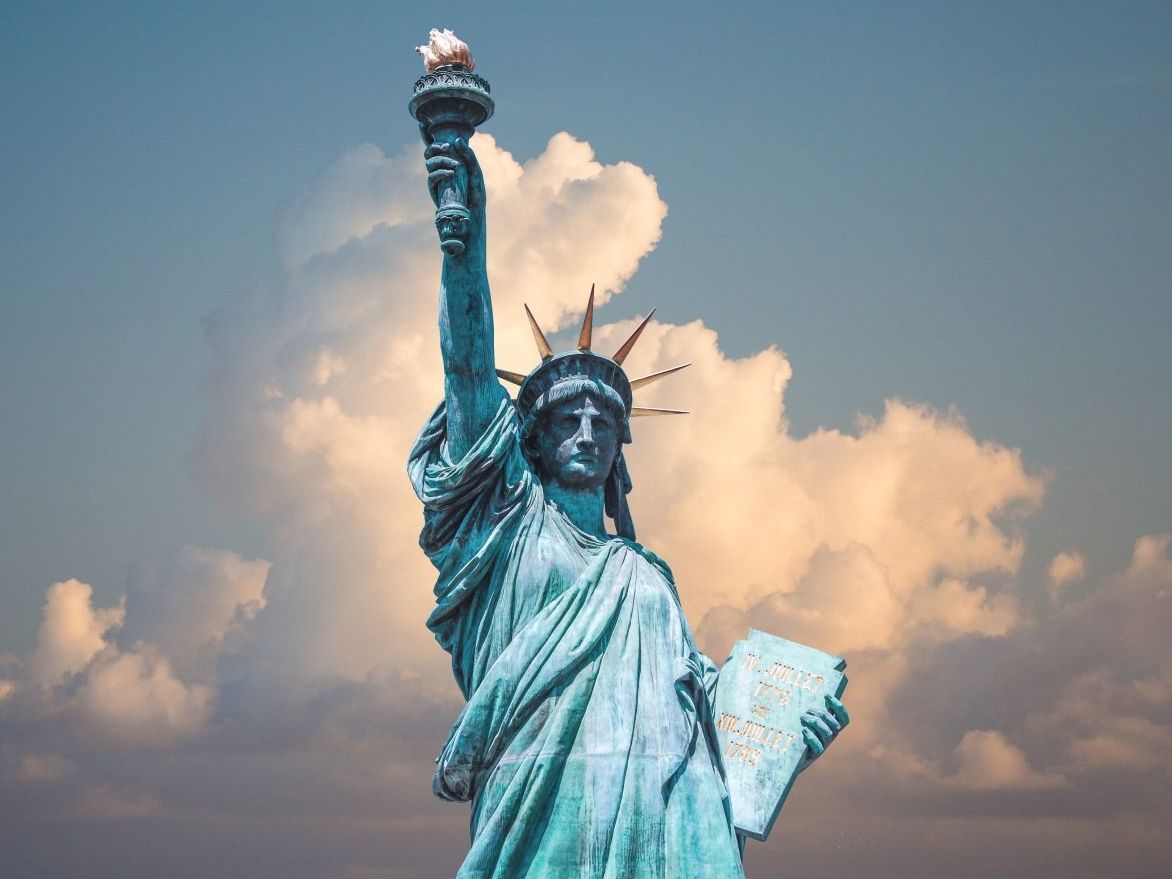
[0,2,1172,876]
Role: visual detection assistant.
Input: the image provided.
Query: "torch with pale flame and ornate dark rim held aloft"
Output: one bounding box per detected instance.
[407,29,493,257]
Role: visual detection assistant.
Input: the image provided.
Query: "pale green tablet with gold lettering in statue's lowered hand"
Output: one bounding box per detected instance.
[713,629,846,839]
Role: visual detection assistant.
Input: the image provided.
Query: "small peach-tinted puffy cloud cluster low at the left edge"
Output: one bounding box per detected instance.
[0,560,256,754]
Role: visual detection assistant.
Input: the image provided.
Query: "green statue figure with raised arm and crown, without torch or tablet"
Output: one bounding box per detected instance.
[409,27,847,879]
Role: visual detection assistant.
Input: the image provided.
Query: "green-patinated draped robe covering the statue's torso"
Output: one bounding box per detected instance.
[408,398,744,879]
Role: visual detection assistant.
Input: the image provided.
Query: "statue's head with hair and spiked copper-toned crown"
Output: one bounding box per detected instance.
[497,288,687,540]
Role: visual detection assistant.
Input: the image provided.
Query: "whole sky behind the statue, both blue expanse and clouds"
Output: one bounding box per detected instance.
[0,2,1172,879]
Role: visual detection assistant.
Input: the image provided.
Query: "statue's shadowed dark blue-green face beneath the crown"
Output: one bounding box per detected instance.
[538,394,619,490]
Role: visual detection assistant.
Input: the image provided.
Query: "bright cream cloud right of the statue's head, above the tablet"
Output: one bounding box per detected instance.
[595,321,1044,649]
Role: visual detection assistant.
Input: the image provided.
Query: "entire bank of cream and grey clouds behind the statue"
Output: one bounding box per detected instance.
[0,134,1172,877]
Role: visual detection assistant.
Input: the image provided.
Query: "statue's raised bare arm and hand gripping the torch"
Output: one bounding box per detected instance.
[423,138,506,458]
